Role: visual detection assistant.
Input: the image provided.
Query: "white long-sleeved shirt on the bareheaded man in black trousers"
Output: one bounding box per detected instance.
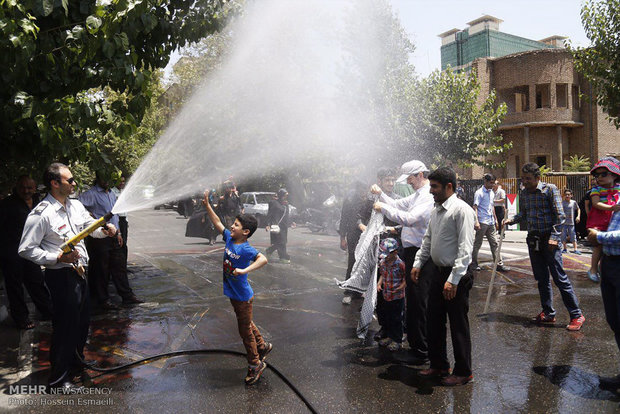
[413,194,476,285]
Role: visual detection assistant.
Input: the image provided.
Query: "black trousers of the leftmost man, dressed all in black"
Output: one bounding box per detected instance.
[1,255,52,324]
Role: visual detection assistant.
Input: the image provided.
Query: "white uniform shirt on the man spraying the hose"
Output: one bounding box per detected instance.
[18,194,107,269]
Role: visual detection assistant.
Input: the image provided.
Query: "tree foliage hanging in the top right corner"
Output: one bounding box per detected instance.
[569,0,620,128]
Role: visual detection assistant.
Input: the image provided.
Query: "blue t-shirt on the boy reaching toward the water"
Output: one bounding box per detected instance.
[222,229,258,302]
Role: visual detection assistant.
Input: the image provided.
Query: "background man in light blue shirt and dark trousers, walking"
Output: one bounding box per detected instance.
[472,174,510,272]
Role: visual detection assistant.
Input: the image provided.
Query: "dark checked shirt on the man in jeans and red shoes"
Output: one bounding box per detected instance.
[512,181,566,239]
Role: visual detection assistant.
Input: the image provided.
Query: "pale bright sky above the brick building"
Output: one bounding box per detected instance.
[391,0,589,76]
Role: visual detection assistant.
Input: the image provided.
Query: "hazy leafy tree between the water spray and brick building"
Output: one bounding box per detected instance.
[413,68,512,168]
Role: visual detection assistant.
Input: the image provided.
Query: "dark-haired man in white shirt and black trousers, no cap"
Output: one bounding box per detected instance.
[411,167,476,386]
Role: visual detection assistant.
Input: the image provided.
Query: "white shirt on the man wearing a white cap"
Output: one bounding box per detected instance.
[379,183,434,247]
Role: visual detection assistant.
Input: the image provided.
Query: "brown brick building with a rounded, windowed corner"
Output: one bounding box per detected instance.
[442,16,620,178]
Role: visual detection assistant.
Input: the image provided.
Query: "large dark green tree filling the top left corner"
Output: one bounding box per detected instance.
[0,0,234,186]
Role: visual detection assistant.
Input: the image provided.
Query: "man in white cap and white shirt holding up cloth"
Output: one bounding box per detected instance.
[371,160,433,365]
